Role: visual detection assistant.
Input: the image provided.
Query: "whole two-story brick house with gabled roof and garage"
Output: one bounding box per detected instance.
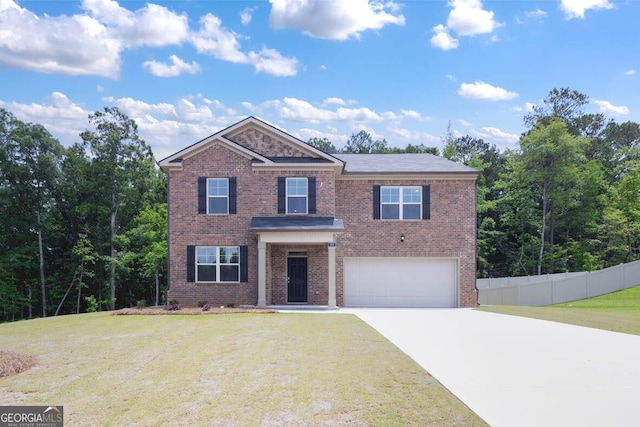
[159,117,478,307]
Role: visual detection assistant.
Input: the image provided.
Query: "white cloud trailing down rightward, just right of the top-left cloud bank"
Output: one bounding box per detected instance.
[191,13,298,76]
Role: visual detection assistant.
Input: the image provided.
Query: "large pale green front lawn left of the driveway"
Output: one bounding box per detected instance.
[0,313,486,426]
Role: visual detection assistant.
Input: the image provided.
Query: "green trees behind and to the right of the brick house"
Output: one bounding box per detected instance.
[309,88,640,277]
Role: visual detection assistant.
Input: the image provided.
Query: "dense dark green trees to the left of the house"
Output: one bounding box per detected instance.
[0,108,167,321]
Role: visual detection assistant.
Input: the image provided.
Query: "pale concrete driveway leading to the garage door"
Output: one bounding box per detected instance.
[340,309,640,427]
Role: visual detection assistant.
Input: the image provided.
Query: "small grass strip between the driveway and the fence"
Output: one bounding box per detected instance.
[478,286,640,335]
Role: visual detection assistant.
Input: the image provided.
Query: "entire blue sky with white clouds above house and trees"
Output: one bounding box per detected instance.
[0,0,640,159]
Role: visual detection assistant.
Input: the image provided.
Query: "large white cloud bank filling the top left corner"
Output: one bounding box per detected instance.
[0,0,189,78]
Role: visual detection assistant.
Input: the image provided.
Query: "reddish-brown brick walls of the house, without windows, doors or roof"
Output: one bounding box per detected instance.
[168,126,477,307]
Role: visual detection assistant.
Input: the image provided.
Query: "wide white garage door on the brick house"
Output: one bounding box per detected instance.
[344,258,458,307]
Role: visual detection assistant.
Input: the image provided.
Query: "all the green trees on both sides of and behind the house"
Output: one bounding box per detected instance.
[0,88,640,321]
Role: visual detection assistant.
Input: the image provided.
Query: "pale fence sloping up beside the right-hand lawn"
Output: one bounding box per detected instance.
[476,261,640,306]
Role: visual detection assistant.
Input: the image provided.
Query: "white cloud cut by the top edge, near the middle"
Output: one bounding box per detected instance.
[269,0,404,40]
